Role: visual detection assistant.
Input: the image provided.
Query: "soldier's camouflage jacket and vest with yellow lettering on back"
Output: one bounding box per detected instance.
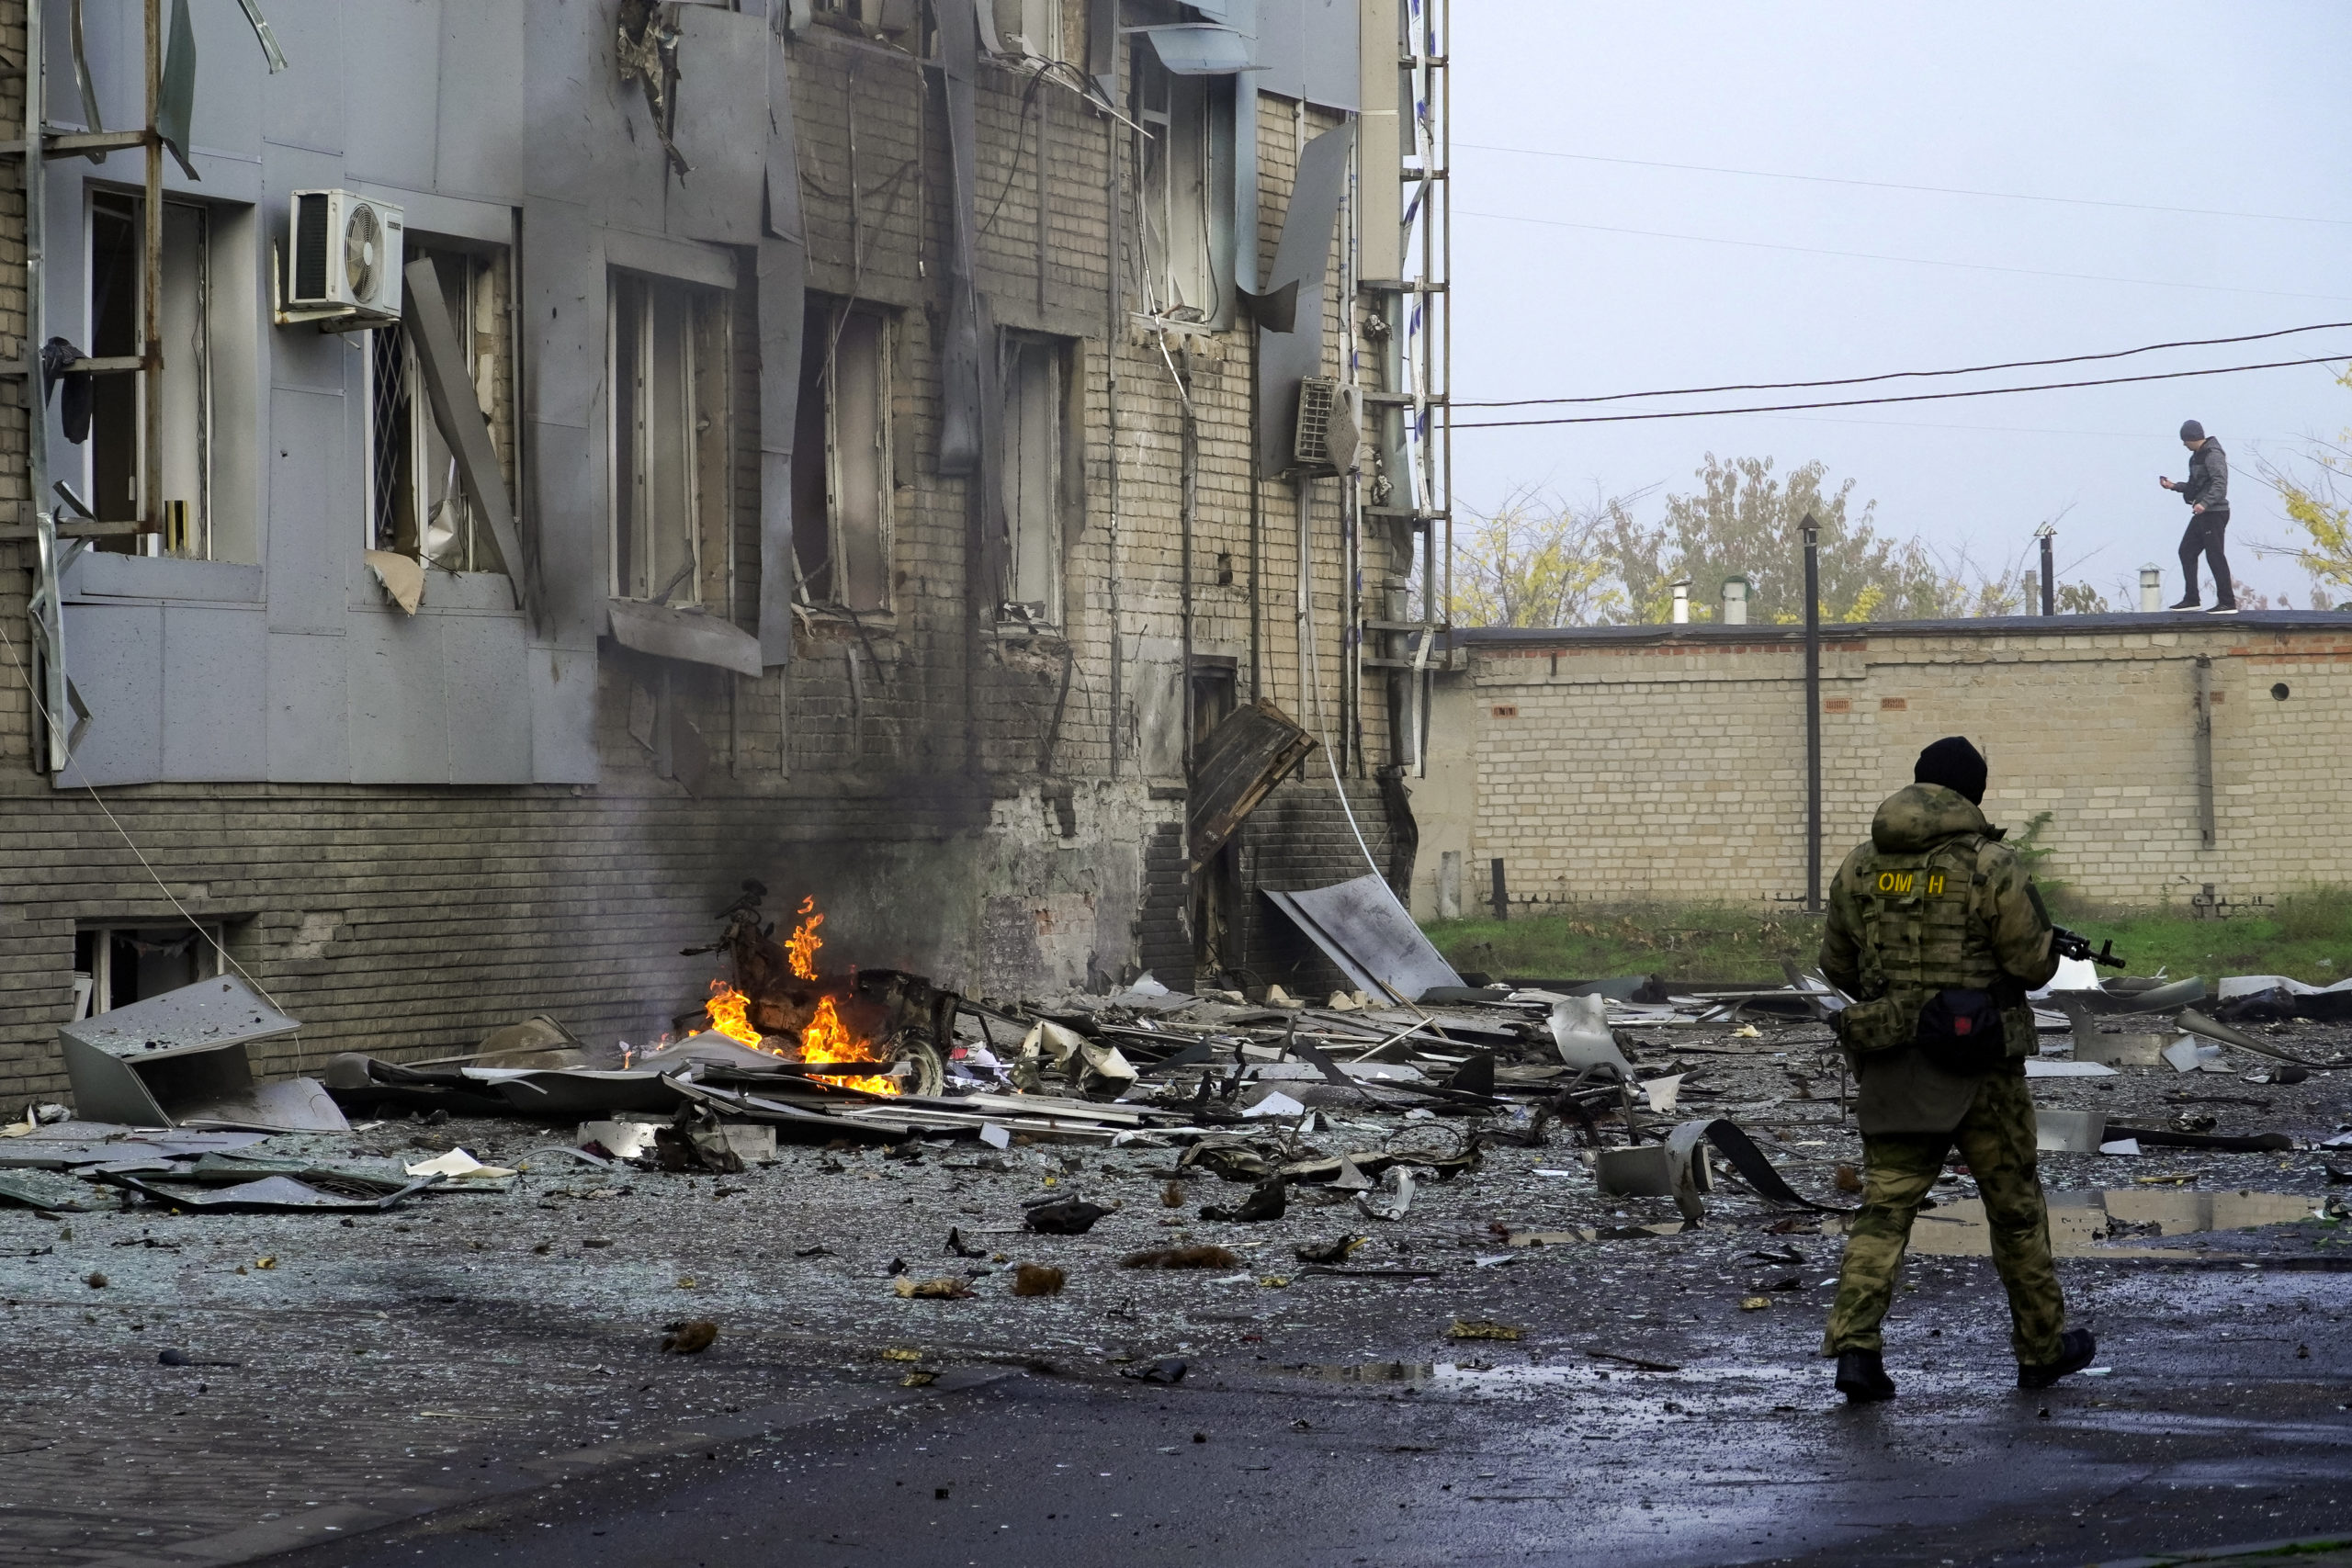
[1820,783,2058,1138]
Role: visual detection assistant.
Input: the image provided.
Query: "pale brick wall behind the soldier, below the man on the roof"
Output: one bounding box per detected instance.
[1414,614,2352,915]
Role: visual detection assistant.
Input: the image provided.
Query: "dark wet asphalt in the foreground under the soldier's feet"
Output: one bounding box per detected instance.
[257,1260,2352,1568]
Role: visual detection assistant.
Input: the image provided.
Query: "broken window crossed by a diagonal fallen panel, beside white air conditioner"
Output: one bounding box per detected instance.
[365,243,513,571]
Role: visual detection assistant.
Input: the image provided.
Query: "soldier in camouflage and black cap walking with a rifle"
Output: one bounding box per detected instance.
[1820,736,2096,1404]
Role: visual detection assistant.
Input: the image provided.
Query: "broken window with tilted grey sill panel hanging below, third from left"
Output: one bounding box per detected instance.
[612,273,729,604]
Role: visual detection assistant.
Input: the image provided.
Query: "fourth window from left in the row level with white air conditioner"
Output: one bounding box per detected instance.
[793,299,894,611]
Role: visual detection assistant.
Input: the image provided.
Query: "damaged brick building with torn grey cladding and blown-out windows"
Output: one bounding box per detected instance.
[0,0,1449,1093]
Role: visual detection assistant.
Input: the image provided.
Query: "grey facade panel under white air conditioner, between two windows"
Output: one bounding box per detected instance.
[264,388,360,632]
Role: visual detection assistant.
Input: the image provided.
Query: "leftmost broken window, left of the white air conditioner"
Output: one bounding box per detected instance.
[87,190,211,559]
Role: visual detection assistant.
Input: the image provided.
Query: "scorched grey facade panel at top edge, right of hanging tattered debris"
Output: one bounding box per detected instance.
[668,5,783,244]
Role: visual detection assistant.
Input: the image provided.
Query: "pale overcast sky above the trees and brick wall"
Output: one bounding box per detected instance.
[1452,0,2352,609]
